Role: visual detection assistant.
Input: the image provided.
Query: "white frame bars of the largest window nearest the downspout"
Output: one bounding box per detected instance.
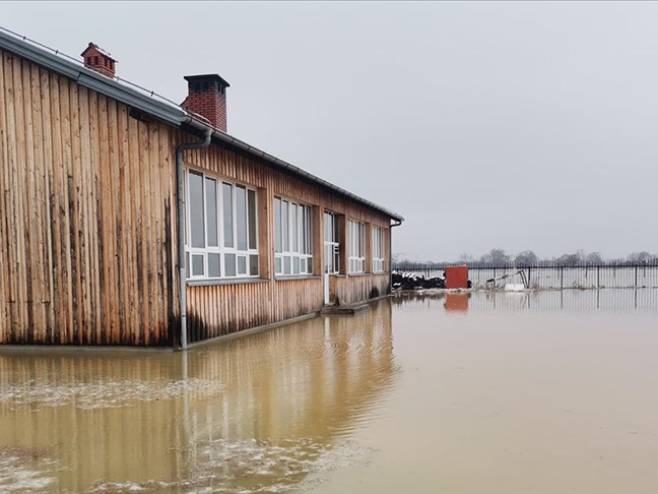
[185,168,260,281]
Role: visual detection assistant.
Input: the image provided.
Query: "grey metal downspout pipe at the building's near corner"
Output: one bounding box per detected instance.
[176,127,212,350]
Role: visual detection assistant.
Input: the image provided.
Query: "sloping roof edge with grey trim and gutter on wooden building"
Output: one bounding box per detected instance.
[0,27,404,221]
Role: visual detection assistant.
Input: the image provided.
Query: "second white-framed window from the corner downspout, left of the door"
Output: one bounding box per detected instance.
[274,197,313,275]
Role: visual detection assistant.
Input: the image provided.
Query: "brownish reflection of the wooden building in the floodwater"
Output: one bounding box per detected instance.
[0,300,395,492]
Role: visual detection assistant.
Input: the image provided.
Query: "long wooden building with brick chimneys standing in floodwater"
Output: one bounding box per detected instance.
[0,31,402,347]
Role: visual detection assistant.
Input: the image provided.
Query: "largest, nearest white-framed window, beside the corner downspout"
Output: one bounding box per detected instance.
[185,170,258,279]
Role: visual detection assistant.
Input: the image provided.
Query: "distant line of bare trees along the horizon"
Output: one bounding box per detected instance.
[393,249,658,267]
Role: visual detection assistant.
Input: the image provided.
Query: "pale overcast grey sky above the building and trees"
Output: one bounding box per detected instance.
[0,2,658,260]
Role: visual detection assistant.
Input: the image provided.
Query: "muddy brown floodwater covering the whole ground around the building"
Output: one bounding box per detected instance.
[0,289,658,494]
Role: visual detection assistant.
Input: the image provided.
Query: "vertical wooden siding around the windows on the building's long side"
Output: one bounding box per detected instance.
[179,144,390,341]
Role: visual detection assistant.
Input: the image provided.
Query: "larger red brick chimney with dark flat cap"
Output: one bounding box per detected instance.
[182,74,230,132]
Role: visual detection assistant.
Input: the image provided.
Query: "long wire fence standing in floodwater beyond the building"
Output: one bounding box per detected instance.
[393,262,658,289]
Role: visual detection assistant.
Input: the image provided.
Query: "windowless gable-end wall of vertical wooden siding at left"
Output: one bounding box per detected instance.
[0,51,177,345]
